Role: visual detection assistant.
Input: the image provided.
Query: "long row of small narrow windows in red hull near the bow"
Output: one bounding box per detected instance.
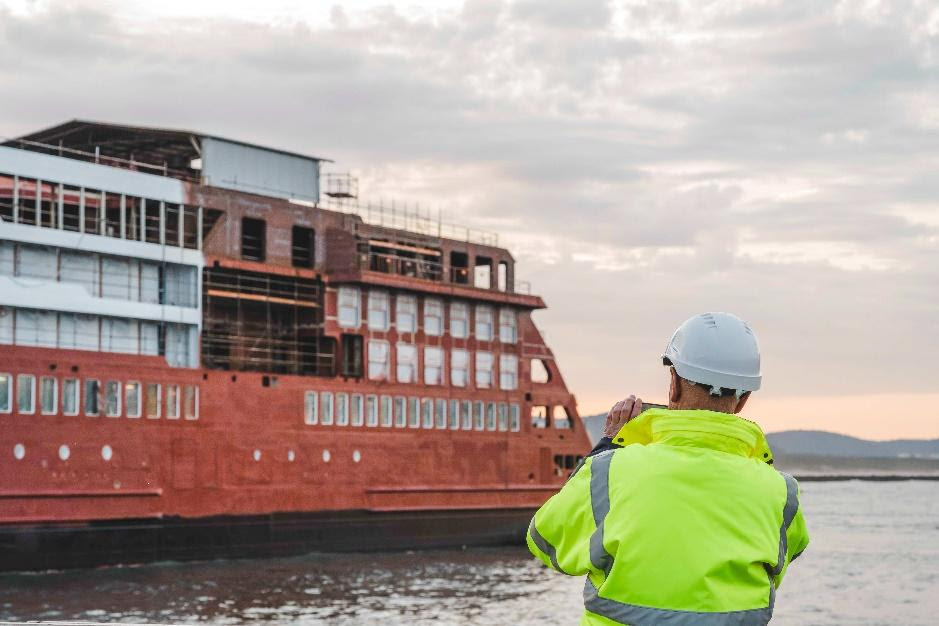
[304,391,521,432]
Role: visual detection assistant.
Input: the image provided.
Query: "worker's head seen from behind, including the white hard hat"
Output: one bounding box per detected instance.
[662,313,762,413]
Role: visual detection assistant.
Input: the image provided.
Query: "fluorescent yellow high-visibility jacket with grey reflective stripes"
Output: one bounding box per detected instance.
[528,409,809,626]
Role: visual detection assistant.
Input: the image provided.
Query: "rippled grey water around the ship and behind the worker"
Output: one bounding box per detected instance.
[0,482,939,626]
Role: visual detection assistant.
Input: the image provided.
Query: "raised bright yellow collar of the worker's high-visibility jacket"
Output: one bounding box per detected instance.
[613,409,773,463]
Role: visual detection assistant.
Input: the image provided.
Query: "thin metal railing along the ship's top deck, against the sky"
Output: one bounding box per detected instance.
[321,196,499,247]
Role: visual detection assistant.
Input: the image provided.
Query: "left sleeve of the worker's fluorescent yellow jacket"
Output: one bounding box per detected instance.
[527,448,596,576]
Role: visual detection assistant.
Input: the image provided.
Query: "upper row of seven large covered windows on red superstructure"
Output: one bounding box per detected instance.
[339,287,518,343]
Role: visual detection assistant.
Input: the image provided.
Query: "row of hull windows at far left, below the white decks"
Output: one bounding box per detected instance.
[0,373,199,420]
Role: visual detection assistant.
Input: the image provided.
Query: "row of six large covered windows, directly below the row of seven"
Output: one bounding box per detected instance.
[368,339,518,391]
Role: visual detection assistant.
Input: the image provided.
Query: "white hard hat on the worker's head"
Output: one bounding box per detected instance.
[662,313,762,397]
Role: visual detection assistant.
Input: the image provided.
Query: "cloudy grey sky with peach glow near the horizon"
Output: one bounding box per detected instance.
[0,0,939,439]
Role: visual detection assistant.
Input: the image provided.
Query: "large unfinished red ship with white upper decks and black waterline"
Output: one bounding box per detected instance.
[0,120,589,569]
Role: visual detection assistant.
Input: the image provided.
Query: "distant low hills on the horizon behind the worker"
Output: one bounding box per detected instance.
[583,414,939,459]
